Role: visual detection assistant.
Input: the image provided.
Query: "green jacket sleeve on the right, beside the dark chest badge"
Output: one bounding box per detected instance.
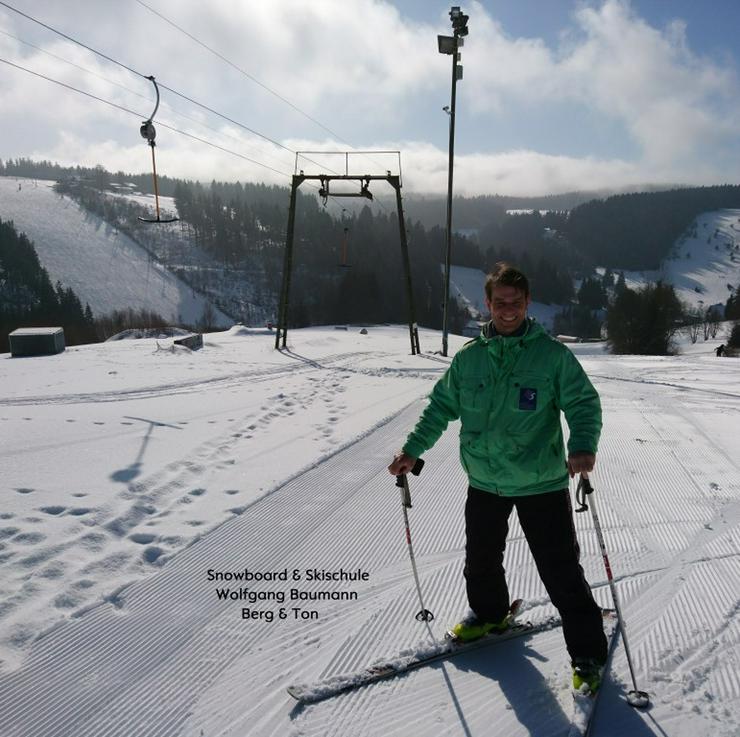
[557,348,601,454]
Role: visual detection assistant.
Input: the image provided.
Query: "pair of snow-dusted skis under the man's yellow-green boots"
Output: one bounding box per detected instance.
[288,599,619,737]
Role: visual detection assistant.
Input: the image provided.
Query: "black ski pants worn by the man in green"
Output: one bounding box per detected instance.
[465,486,607,661]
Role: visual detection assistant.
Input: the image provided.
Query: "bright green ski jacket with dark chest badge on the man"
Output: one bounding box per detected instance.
[403,319,601,496]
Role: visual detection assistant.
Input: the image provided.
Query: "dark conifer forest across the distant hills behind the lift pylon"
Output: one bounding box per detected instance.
[0,159,740,350]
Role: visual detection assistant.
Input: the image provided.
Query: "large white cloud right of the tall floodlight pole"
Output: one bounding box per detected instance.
[468,0,740,167]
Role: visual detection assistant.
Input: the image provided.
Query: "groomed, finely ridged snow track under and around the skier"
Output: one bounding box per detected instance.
[0,360,740,737]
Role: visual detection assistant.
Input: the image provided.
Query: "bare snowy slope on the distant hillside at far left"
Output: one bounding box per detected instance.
[0,177,233,326]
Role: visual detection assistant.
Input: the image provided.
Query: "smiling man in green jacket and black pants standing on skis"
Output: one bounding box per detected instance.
[388,263,607,691]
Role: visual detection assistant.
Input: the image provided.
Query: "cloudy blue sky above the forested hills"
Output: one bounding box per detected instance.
[0,0,740,196]
